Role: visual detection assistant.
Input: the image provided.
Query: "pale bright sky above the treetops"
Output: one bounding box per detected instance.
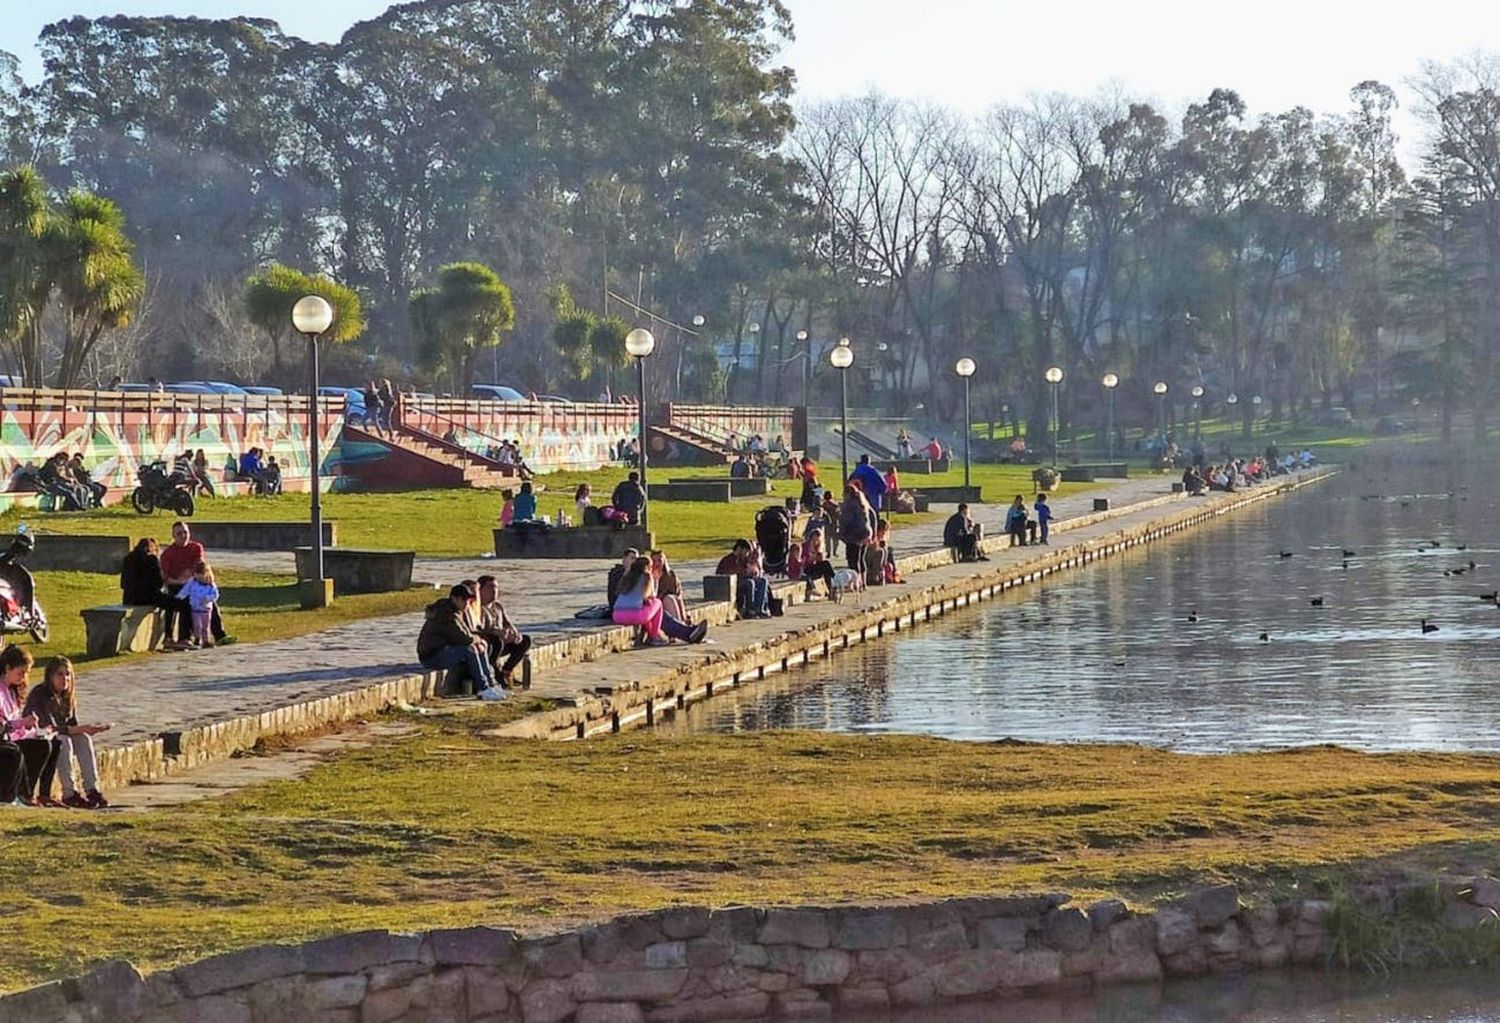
[0,0,1500,161]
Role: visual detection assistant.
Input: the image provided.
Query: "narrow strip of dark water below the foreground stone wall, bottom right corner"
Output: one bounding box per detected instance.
[843,972,1500,1023]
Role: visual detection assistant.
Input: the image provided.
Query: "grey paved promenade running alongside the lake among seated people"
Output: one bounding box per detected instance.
[80,477,1170,746]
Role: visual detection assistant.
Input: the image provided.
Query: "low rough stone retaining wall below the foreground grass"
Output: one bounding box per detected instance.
[11,878,1500,1023]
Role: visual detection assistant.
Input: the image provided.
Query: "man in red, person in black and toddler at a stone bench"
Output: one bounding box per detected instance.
[120,522,234,650]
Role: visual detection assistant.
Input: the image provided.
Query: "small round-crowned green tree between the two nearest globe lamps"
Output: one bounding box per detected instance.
[408,263,516,395]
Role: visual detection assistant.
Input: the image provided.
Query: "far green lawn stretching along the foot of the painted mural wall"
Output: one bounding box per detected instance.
[0,459,1088,558]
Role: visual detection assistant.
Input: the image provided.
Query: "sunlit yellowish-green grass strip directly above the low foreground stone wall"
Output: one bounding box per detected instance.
[0,717,1500,989]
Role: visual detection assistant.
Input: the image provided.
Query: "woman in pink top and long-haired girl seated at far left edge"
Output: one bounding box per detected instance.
[0,644,110,810]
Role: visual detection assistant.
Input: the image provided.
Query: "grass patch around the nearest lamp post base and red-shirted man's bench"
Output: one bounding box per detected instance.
[15,569,434,672]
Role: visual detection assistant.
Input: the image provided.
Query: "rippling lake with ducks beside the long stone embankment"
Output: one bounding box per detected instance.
[663,449,1500,753]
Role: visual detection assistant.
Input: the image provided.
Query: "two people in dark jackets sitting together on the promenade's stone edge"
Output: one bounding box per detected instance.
[417,576,531,701]
